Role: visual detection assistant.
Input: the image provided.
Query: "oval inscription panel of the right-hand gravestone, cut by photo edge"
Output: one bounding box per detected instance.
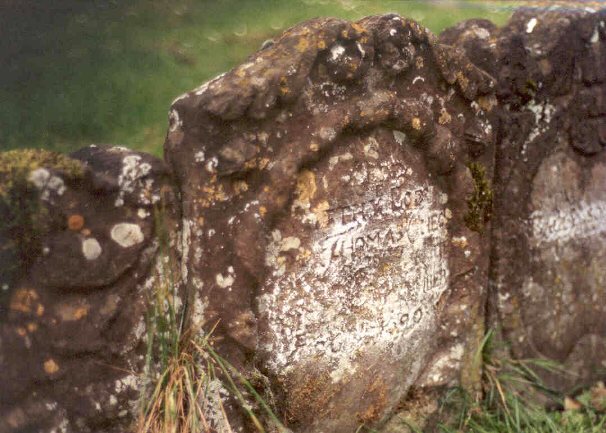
[520,151,606,356]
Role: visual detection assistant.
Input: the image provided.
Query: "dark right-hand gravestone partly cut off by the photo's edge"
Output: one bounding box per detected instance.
[442,9,606,389]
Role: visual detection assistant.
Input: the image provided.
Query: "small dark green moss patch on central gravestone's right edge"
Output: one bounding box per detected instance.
[465,162,492,233]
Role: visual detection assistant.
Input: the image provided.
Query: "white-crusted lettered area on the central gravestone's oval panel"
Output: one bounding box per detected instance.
[259,154,449,381]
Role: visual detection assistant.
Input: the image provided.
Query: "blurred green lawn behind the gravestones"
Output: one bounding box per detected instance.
[0,0,510,155]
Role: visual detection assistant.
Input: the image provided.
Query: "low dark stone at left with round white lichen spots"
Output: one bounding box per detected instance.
[0,146,179,432]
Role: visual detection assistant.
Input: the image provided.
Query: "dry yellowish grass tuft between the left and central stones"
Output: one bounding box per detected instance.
[135,212,288,433]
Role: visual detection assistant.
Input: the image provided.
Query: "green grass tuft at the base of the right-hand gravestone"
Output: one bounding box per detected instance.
[439,332,606,433]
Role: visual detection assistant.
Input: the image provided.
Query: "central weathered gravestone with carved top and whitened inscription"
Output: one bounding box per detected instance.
[165,15,495,433]
